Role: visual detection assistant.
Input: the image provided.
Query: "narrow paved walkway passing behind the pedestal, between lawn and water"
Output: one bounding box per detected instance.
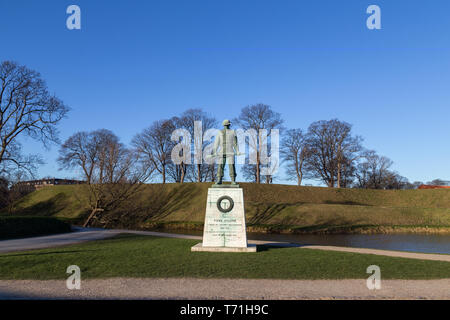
[0,227,450,262]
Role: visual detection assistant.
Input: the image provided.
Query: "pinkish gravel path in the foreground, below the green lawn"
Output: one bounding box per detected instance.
[0,278,450,300]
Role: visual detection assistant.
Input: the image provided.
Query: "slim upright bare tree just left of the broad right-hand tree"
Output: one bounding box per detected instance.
[281,129,308,186]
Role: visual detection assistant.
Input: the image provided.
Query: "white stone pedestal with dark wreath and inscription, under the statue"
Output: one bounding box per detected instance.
[191,185,256,252]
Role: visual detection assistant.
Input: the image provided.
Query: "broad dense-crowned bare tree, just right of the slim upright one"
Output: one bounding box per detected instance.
[307,119,363,188]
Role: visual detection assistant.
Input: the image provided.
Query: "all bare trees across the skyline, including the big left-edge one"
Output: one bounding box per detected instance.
[0,61,438,194]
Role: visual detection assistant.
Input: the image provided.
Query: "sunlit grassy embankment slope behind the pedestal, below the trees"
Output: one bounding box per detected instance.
[2,183,450,233]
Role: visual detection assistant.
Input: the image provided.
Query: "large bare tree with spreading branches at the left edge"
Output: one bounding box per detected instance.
[0,61,68,174]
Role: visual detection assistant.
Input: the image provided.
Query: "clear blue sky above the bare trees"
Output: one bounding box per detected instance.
[0,0,450,181]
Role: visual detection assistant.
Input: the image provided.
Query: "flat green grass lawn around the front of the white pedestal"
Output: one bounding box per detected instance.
[0,235,450,280]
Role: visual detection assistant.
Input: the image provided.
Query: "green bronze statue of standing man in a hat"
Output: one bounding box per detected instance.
[213,120,241,185]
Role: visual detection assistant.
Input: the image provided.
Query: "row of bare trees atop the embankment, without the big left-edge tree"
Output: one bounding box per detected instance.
[58,104,414,189]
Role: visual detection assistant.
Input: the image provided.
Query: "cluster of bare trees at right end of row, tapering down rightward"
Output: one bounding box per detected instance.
[281,119,417,189]
